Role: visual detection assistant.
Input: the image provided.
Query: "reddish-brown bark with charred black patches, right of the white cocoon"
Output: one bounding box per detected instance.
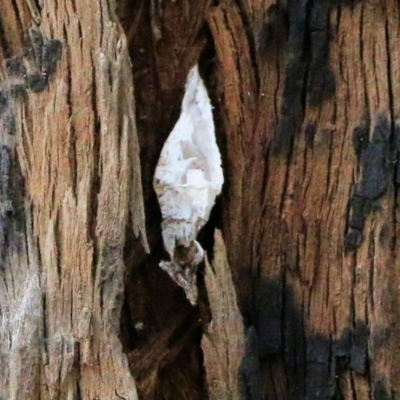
[208,1,400,399]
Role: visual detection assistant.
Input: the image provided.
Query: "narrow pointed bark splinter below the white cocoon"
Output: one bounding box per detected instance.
[201,230,247,400]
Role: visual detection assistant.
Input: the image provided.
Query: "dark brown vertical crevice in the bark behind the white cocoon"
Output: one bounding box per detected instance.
[119,1,219,400]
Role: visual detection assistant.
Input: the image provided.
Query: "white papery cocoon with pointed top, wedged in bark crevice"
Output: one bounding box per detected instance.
[153,65,224,304]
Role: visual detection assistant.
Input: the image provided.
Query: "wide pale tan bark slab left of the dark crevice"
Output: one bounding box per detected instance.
[0,0,146,400]
